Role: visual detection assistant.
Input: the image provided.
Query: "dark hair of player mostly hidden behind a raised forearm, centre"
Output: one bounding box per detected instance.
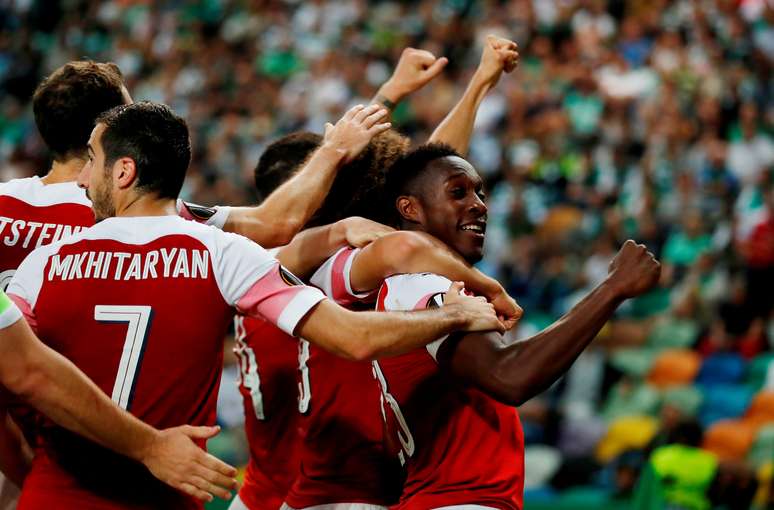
[254,131,322,201]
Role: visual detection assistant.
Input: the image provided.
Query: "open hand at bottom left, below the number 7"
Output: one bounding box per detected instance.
[142,425,237,501]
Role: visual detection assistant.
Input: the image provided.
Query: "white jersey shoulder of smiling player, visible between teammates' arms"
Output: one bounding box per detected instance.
[378,273,452,310]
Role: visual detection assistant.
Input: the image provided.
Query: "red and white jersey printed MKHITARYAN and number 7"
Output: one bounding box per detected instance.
[8,216,324,510]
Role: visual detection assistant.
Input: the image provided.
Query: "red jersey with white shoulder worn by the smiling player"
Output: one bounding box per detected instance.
[374,273,524,510]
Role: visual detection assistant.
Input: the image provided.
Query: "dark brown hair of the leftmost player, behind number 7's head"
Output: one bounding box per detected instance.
[32,60,124,161]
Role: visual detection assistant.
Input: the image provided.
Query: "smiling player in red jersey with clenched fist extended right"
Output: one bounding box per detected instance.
[370,144,660,510]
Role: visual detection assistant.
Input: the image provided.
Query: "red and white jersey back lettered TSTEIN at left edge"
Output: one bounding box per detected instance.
[0,177,94,289]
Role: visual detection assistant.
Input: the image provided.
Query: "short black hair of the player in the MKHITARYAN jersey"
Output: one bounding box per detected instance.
[97,101,191,198]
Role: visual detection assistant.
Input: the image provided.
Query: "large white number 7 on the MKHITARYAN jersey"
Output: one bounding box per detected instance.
[94,305,153,410]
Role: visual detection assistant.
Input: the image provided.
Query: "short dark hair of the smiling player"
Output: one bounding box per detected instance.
[382,143,462,225]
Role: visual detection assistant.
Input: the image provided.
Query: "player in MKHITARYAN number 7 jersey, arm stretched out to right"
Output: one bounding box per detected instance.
[4,102,503,510]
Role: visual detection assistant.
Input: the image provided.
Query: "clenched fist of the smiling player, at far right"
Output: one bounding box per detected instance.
[608,239,661,298]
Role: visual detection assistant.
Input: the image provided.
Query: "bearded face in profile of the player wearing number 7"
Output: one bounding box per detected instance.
[78,124,116,221]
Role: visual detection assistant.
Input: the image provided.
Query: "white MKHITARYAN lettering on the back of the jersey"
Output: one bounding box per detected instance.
[46,248,210,281]
